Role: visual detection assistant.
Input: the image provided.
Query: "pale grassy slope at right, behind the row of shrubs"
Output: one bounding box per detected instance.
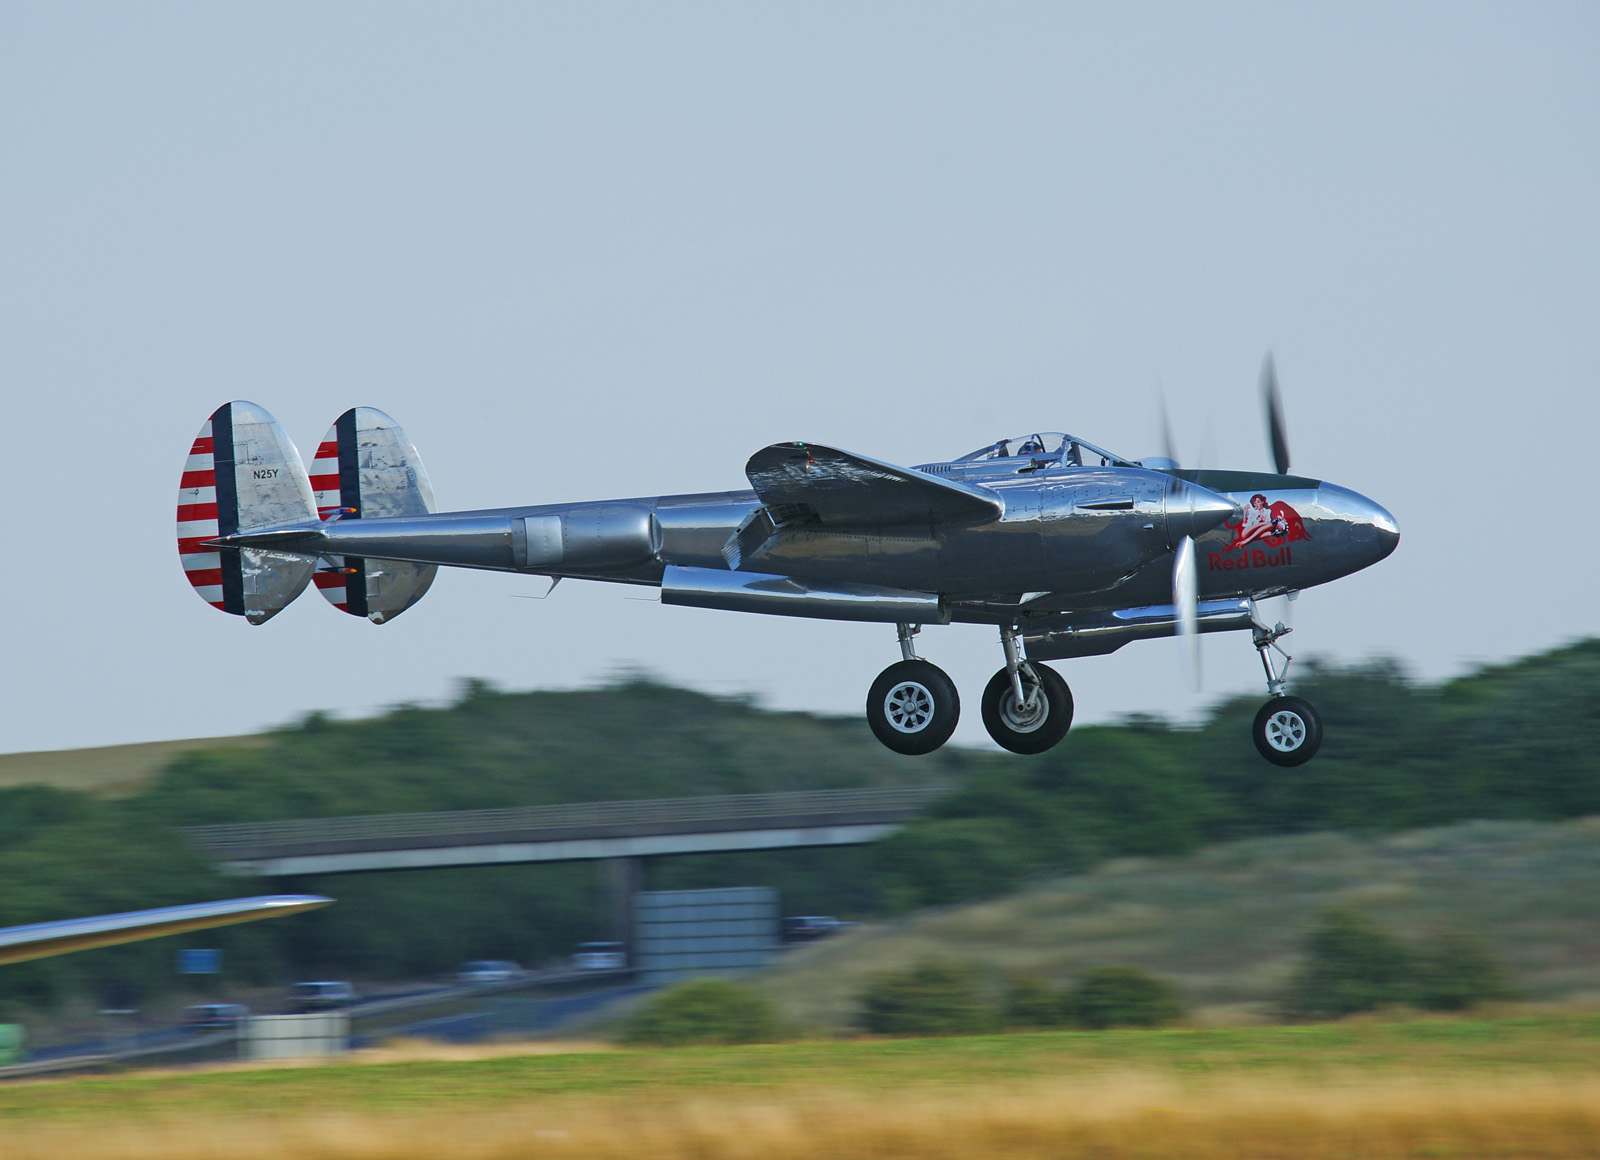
[760,818,1600,1029]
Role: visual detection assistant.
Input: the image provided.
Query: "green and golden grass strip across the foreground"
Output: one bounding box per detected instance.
[0,1013,1600,1160]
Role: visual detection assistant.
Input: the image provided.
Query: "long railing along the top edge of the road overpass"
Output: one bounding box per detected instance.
[184,786,947,861]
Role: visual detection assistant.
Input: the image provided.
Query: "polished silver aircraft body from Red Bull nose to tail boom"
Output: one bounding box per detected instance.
[240,459,1398,634]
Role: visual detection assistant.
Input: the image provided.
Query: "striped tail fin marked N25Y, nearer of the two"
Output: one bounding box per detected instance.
[178,400,315,624]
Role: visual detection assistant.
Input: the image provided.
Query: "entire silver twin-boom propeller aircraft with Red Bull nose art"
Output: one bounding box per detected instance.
[178,358,1400,766]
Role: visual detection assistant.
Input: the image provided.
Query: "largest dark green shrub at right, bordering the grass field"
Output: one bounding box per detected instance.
[1285,910,1510,1019]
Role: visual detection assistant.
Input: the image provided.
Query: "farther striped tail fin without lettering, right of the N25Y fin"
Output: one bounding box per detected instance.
[310,406,438,624]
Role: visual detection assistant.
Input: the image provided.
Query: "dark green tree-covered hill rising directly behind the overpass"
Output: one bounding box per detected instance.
[142,680,978,826]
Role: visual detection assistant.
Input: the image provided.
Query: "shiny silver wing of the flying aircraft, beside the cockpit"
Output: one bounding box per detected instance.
[744,443,1005,526]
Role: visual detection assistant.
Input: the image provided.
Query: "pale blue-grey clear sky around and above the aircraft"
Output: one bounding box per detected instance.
[0,3,1600,750]
